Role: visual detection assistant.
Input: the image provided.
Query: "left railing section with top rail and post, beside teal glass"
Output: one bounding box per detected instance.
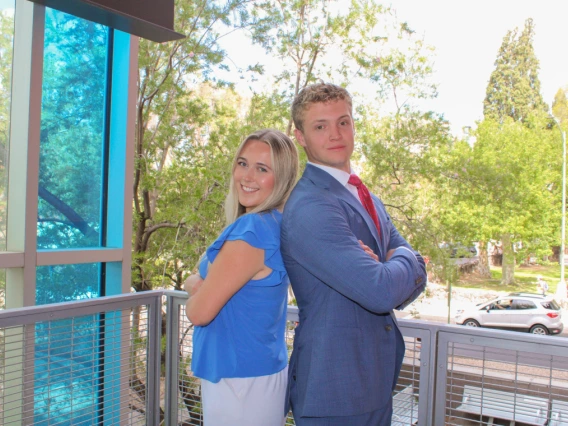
[0,292,163,425]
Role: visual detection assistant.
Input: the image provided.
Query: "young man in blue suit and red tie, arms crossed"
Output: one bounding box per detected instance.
[281,83,426,426]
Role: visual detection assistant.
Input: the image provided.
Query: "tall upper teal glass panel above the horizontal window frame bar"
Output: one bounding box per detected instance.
[37,8,109,249]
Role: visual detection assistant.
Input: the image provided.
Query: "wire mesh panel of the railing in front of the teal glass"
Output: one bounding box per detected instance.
[0,302,153,425]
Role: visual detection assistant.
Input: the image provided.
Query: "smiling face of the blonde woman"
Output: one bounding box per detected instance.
[233,140,274,212]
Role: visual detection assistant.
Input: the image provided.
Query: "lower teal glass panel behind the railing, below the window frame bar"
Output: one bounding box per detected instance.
[34,263,104,425]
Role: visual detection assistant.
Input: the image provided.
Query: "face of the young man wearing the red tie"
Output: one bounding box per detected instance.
[294,99,355,173]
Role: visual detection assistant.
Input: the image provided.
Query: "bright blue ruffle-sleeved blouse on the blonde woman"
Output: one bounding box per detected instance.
[191,210,289,383]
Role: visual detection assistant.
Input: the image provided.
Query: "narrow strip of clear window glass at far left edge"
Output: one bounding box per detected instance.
[0,0,15,251]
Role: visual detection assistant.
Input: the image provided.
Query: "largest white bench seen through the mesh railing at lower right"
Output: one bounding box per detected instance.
[457,385,548,425]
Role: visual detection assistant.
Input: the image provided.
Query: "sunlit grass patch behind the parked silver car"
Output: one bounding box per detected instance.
[454,264,560,294]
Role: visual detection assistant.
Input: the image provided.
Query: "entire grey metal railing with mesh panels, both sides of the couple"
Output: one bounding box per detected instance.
[0,291,568,426]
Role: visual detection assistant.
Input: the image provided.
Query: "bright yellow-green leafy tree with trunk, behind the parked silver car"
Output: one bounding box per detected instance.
[445,115,561,285]
